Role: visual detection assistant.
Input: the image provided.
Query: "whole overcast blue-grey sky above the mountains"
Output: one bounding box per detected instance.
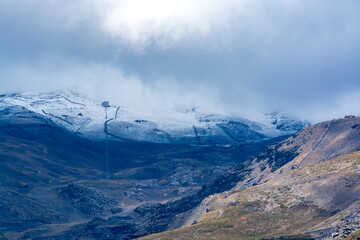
[0,0,360,122]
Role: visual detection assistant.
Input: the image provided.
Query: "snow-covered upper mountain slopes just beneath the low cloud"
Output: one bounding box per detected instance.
[0,91,309,145]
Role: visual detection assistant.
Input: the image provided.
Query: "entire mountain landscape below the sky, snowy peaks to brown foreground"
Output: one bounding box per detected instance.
[0,92,360,239]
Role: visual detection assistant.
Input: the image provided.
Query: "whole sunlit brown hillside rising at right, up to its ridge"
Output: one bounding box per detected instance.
[140,117,360,239]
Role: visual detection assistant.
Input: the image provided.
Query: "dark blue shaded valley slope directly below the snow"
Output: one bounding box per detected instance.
[0,106,282,239]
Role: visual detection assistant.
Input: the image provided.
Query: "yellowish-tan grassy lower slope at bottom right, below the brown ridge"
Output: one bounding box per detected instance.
[142,152,360,240]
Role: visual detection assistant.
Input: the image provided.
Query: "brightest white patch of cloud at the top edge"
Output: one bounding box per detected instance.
[93,0,244,48]
